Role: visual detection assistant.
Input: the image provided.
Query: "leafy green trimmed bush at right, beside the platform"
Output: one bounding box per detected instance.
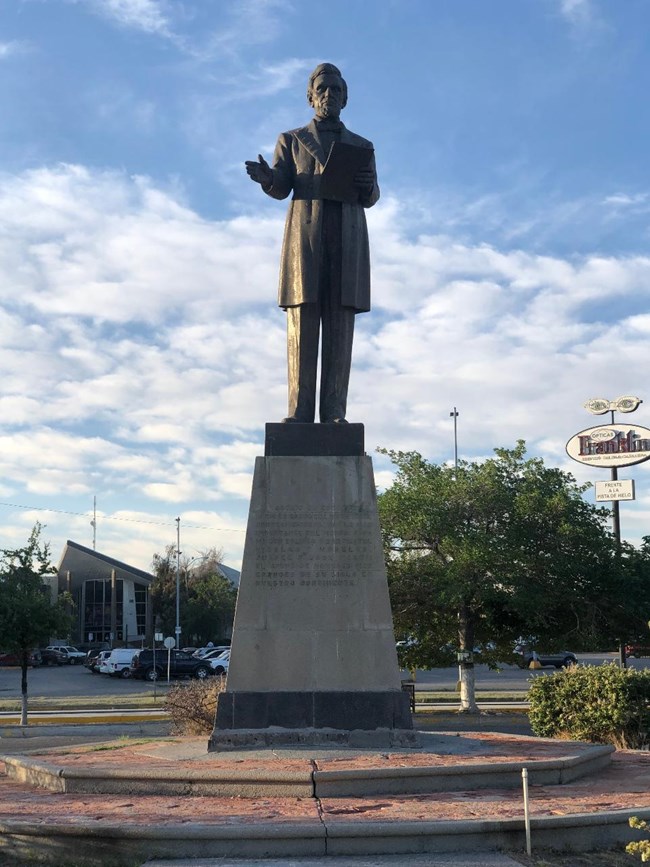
[529,663,650,749]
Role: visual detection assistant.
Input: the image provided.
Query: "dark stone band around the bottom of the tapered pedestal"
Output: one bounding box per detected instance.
[210,690,413,733]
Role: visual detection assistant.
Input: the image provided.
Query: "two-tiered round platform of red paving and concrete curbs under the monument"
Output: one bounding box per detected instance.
[0,732,650,867]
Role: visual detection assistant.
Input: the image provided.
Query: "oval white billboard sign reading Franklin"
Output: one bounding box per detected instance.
[566,424,650,467]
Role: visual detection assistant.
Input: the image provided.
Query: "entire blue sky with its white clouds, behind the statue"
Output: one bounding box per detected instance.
[0,0,650,569]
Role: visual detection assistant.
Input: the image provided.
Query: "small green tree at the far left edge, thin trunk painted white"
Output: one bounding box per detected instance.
[0,523,72,725]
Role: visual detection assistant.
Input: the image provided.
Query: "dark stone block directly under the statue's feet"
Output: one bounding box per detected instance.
[264,422,364,457]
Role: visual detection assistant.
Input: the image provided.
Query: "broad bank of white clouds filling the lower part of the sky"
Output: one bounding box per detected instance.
[0,166,650,568]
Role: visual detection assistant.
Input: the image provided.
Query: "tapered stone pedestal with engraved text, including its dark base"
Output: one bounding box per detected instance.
[209,425,415,750]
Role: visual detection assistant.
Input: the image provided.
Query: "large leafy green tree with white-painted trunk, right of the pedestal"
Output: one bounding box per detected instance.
[379,441,624,712]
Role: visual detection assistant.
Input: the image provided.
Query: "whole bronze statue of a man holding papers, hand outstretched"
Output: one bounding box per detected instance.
[246,63,379,423]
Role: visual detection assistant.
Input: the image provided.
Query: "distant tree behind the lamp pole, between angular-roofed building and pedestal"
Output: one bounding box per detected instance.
[151,545,237,644]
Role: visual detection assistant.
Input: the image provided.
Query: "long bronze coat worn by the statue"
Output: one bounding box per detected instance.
[264,120,379,313]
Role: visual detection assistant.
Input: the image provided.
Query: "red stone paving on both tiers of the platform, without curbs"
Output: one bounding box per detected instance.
[0,733,650,825]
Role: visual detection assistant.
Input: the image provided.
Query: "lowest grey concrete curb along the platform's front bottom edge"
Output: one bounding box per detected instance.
[0,808,650,865]
